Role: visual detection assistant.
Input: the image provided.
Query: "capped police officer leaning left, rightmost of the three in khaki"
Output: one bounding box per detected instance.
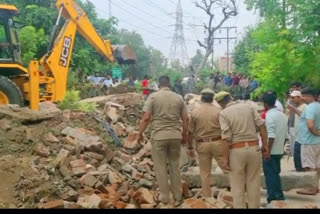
[215,91,268,208]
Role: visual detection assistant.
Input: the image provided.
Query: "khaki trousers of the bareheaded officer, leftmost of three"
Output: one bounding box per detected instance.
[152,140,182,203]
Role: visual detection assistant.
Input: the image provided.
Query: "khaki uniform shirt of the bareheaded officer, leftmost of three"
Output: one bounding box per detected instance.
[143,88,186,140]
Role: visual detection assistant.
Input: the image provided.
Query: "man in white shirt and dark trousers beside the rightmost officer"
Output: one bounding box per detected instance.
[262,93,288,203]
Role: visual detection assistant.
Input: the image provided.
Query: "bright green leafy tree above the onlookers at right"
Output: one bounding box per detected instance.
[234,0,320,98]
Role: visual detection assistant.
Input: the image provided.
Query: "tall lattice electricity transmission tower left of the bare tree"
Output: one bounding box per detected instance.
[169,0,189,66]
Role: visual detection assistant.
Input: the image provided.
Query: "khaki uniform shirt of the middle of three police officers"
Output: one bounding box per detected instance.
[189,103,221,141]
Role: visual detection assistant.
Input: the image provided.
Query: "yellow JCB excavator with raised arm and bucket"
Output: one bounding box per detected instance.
[0,0,137,110]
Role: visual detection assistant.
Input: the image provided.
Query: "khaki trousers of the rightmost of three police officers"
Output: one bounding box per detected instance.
[230,146,262,208]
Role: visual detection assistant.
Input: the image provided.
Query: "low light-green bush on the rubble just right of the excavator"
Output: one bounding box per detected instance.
[58,90,97,113]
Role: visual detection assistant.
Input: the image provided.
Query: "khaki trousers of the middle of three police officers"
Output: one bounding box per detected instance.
[197,140,228,198]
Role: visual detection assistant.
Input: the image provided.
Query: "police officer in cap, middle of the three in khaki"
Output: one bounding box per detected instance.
[188,88,228,198]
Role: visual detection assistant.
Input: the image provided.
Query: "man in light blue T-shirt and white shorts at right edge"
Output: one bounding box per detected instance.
[297,87,320,195]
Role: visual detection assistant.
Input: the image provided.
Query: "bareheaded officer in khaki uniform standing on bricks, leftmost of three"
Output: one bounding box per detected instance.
[138,76,188,206]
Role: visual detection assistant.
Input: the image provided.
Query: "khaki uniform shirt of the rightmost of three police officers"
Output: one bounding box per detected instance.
[219,102,264,143]
